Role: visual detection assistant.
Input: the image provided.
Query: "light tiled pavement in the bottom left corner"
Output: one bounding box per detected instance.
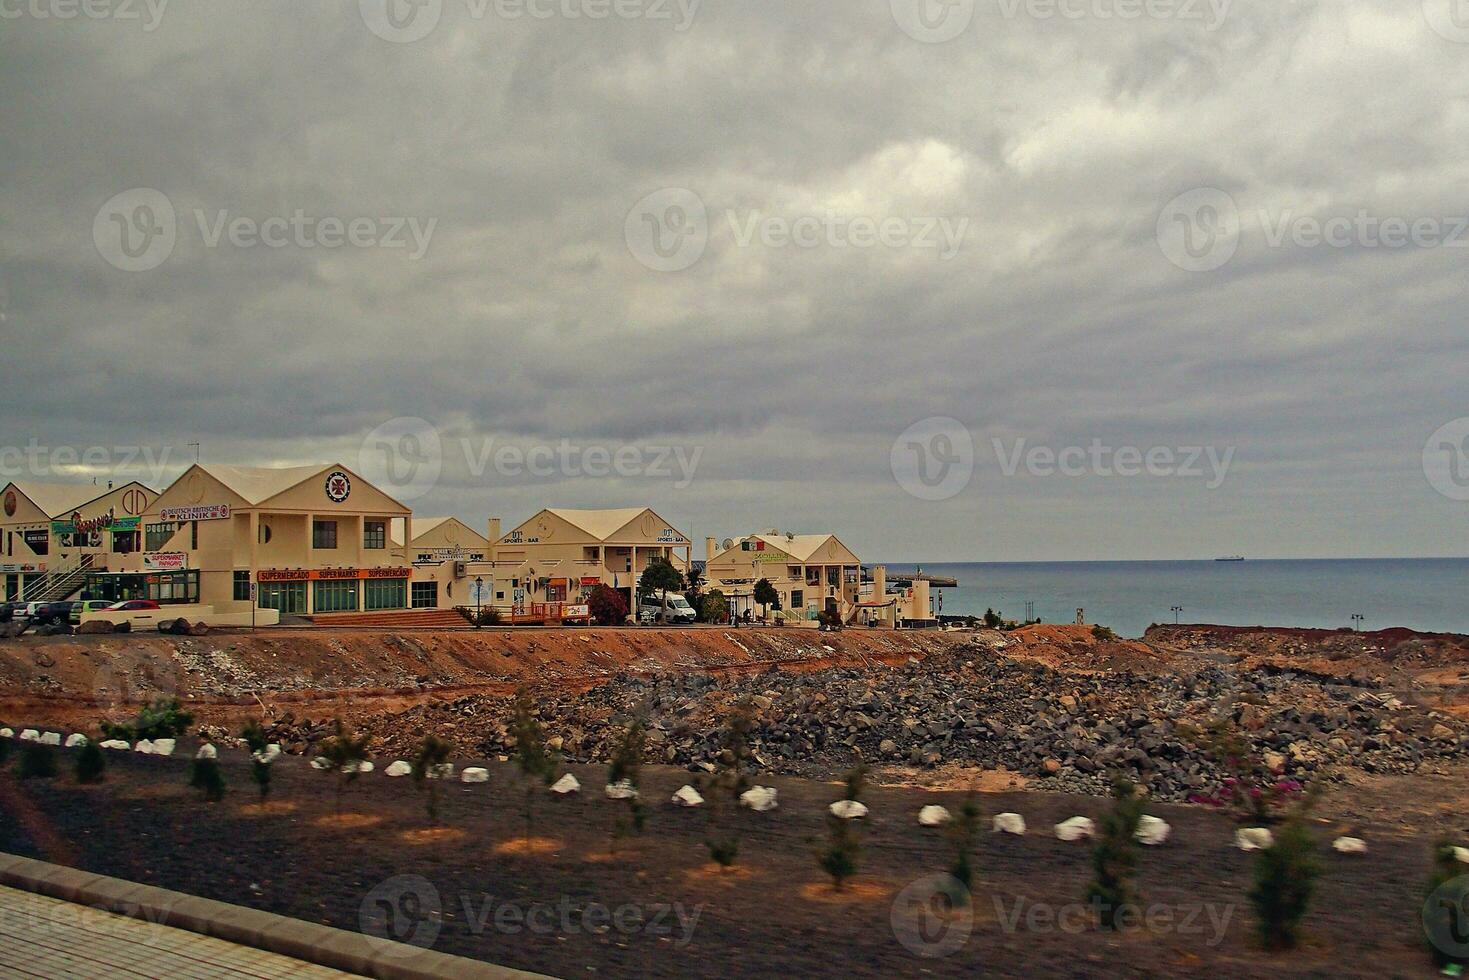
[0,886,361,980]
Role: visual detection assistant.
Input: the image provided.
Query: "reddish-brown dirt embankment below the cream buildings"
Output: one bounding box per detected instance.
[0,629,970,730]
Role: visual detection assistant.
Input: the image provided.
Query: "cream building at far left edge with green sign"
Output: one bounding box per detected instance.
[0,480,159,601]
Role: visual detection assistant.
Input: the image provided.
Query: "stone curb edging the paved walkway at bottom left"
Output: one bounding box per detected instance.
[0,852,549,980]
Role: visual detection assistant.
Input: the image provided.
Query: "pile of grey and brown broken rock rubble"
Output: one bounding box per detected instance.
[352,649,1469,799]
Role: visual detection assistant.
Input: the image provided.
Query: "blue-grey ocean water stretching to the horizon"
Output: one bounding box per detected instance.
[887,558,1469,636]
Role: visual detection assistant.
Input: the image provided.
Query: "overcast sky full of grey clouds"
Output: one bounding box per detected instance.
[0,0,1469,561]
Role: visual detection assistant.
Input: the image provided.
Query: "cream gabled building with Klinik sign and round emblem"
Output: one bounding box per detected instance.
[87,463,413,616]
